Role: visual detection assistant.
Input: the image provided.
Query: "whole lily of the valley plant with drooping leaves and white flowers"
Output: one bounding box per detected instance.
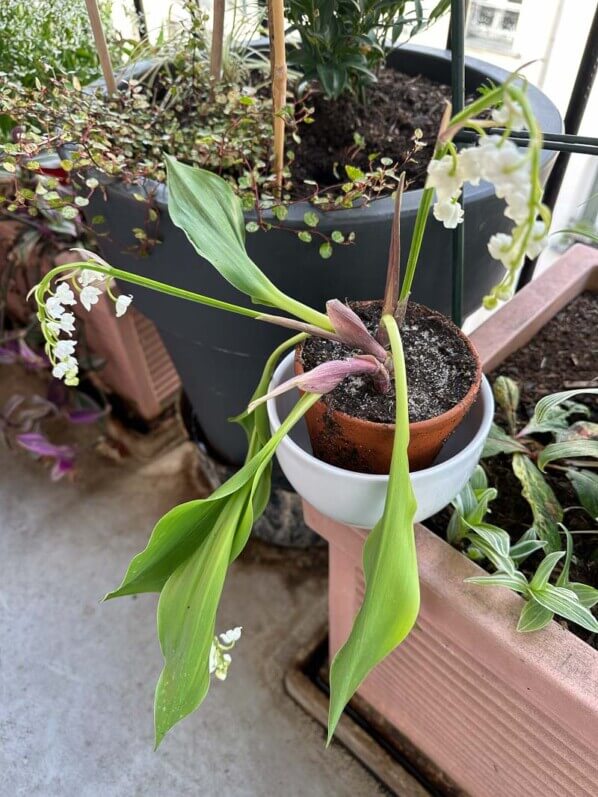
[30,77,549,744]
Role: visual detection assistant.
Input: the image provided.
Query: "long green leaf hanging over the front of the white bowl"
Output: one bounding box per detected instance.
[328,316,419,743]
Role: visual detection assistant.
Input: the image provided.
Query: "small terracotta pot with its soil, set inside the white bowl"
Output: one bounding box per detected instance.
[296,301,482,473]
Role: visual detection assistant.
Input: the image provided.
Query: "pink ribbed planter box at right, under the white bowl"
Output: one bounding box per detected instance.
[304,246,598,797]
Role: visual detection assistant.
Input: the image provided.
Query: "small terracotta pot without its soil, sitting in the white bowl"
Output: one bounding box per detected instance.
[295,302,482,473]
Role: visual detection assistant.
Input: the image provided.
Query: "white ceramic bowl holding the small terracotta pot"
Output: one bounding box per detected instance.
[268,352,494,529]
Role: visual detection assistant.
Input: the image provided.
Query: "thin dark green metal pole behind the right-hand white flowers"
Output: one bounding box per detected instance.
[450,0,465,327]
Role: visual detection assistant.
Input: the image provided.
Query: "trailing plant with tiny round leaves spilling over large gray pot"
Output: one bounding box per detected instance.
[0,0,421,259]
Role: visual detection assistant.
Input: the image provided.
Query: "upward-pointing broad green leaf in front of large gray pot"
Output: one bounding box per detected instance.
[165,155,332,330]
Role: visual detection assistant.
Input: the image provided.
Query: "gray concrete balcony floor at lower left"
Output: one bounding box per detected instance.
[0,368,383,797]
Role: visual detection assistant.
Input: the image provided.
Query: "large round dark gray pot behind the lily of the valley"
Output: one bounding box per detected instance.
[91,46,562,464]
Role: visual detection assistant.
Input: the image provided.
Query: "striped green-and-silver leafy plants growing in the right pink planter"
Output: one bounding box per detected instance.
[447,376,598,633]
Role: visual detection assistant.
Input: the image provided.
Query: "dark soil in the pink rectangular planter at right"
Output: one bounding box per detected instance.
[426,292,598,649]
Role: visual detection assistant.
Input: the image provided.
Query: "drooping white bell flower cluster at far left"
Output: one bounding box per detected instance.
[39,268,133,385]
